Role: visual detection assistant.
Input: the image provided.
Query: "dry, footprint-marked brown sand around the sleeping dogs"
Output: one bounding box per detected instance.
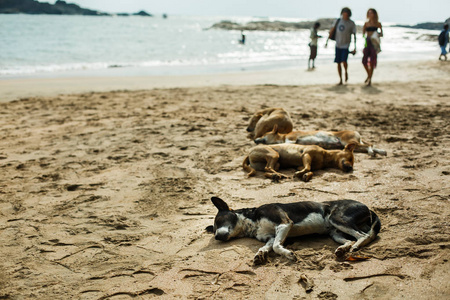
[0,60,450,299]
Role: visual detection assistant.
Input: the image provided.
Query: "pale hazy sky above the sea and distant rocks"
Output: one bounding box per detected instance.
[60,0,450,23]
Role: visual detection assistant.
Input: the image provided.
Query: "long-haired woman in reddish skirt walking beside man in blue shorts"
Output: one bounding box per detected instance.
[362,8,383,86]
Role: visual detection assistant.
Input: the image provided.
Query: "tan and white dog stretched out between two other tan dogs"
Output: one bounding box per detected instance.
[255,125,386,156]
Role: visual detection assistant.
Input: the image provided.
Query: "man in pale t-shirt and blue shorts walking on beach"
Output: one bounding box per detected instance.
[325,7,356,85]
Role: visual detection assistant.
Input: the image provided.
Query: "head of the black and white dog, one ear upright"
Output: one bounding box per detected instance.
[206,197,239,241]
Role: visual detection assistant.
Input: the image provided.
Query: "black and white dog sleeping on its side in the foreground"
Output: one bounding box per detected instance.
[206,197,381,264]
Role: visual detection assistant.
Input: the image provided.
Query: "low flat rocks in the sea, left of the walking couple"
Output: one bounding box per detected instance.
[209,18,348,31]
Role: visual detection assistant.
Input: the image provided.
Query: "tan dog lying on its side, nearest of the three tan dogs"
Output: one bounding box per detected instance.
[242,143,356,181]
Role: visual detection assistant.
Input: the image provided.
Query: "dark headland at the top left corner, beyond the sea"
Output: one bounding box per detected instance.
[0,0,109,16]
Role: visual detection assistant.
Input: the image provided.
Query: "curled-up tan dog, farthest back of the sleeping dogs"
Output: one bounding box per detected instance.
[247,107,293,139]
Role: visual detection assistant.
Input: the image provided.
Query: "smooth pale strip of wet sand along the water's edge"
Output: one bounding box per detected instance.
[0,60,450,102]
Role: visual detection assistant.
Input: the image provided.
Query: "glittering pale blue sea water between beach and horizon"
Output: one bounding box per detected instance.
[0,15,439,78]
